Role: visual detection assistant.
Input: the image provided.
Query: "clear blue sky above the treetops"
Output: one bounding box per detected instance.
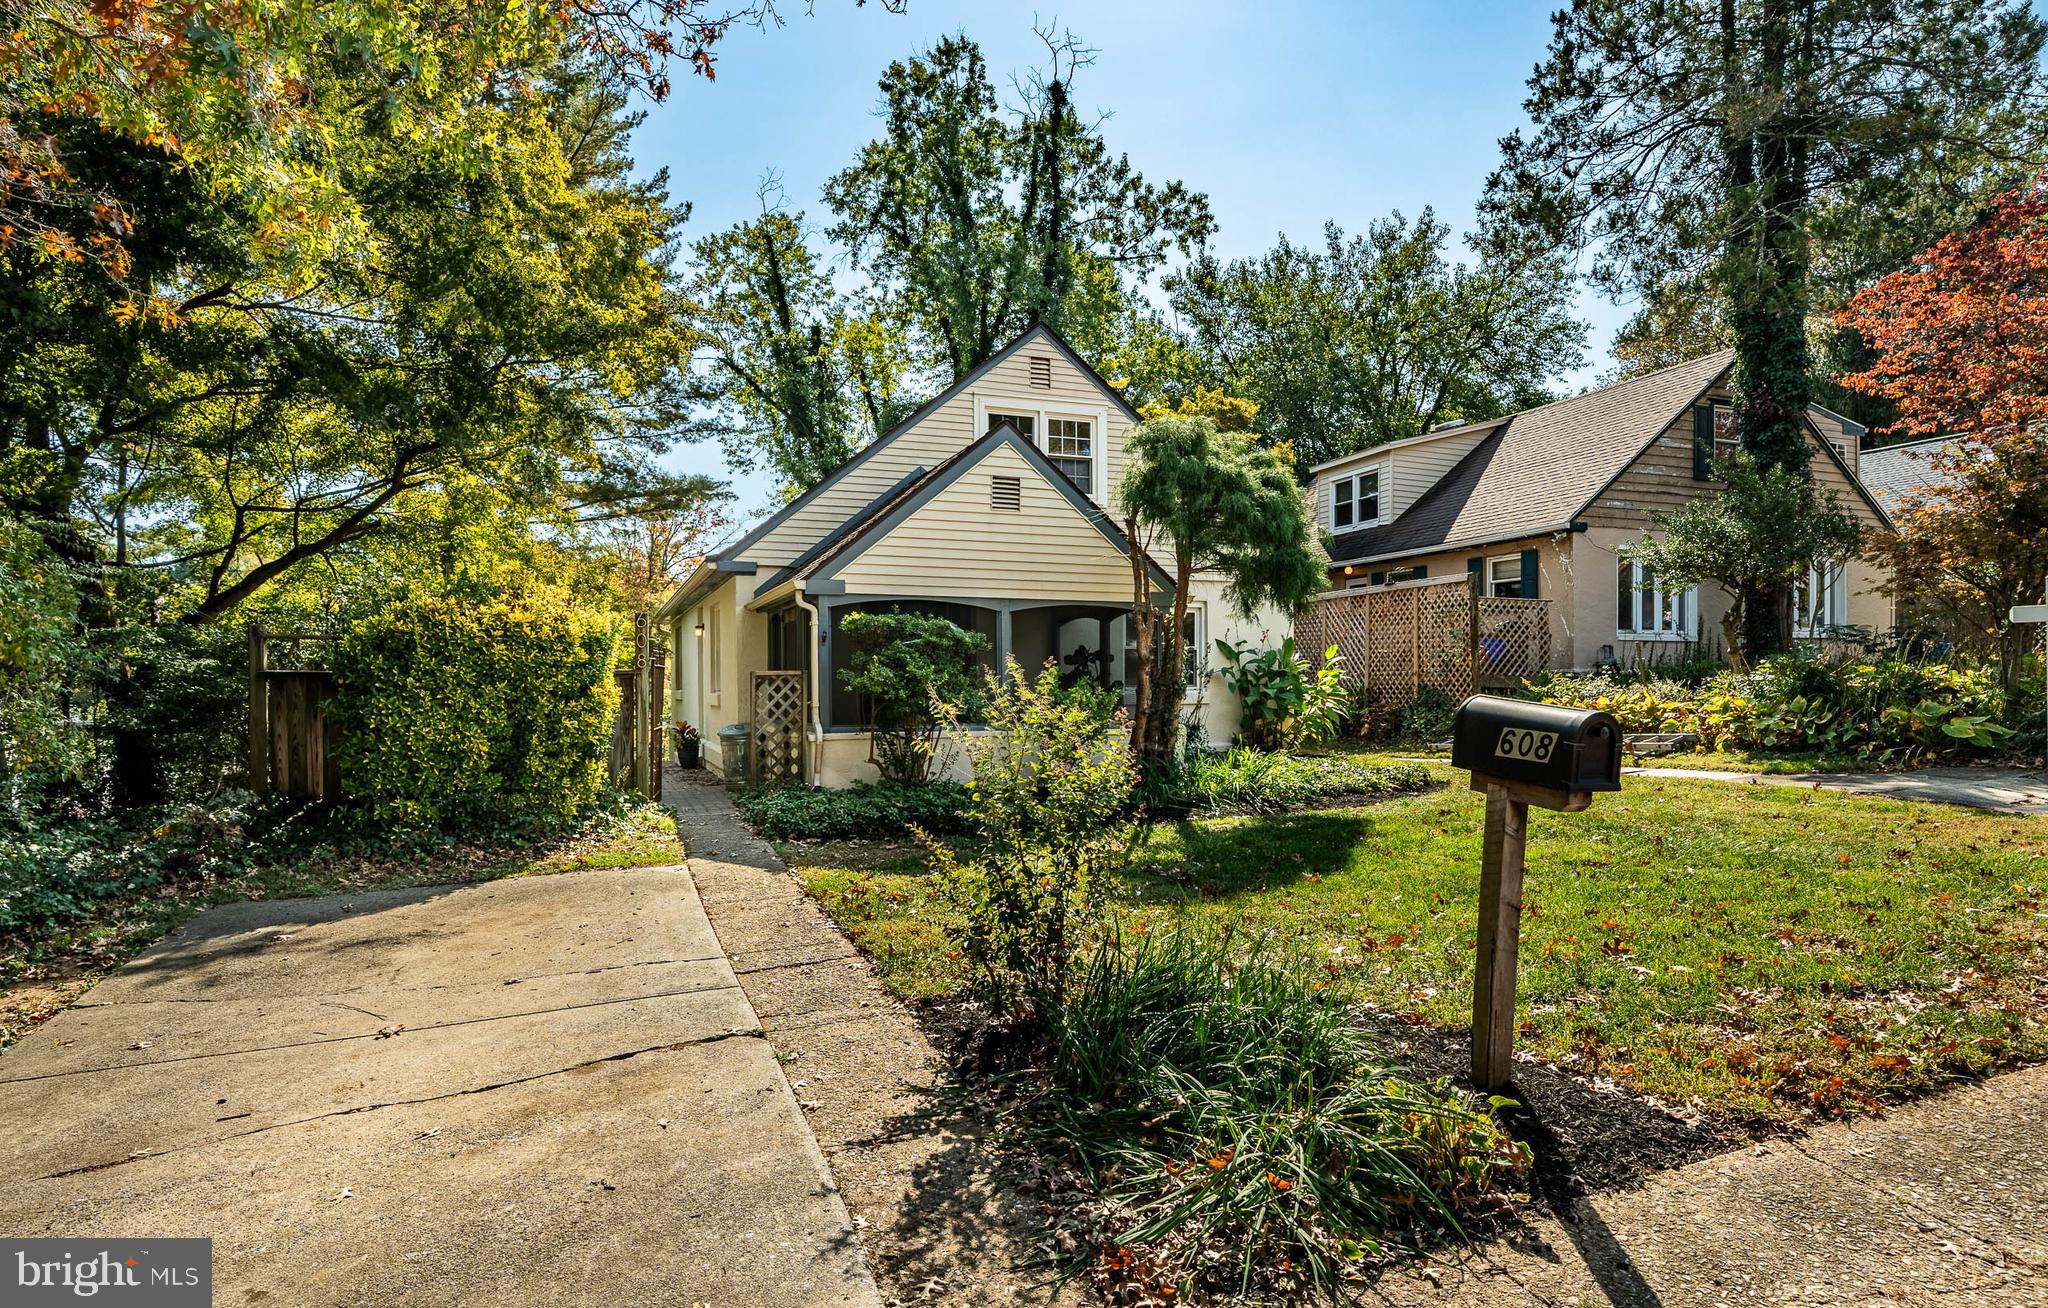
[635,0,1628,510]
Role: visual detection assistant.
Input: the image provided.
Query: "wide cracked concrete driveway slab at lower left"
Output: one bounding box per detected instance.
[0,868,879,1308]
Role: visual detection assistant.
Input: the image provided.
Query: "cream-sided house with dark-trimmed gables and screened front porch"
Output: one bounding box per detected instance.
[659,328,1288,786]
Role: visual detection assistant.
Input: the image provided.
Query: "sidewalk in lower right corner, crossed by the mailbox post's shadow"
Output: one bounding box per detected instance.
[1374,1066,2048,1308]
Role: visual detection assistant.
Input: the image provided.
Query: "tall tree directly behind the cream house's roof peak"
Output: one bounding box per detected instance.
[825,33,1214,381]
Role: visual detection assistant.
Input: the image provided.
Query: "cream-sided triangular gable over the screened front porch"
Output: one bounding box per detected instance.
[805,426,1171,602]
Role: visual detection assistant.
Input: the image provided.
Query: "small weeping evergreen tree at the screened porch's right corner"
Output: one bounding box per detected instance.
[1116,416,1325,761]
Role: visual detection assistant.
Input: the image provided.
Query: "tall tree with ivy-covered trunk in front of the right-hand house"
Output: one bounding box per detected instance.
[1489,0,2048,653]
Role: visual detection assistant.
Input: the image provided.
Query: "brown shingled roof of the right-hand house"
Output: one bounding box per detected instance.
[1329,350,1735,563]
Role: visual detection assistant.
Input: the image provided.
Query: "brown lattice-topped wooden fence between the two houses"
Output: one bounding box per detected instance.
[1294,577,1550,704]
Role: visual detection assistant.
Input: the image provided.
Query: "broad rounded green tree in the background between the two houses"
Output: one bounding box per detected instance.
[1169,209,1585,467]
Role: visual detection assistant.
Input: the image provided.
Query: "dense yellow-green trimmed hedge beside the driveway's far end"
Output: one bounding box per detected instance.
[330,596,618,831]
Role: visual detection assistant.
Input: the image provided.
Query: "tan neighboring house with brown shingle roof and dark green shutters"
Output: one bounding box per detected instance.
[1315,352,1892,667]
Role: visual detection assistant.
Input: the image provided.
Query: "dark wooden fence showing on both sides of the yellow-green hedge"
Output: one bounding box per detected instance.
[248,614,668,804]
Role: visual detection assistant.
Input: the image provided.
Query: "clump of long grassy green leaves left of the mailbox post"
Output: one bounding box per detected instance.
[1014,931,1530,1302]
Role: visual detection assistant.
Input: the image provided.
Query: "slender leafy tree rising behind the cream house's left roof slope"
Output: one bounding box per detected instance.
[684,192,911,495]
